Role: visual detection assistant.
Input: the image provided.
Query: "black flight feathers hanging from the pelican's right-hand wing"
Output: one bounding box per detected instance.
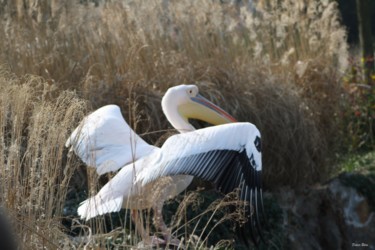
[162,149,265,246]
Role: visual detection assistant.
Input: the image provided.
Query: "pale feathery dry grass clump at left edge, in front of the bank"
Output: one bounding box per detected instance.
[0,70,86,249]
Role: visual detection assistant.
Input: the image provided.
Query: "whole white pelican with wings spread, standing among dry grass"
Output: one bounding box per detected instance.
[66,85,264,244]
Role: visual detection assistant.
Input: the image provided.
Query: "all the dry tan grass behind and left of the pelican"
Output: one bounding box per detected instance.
[0,0,347,249]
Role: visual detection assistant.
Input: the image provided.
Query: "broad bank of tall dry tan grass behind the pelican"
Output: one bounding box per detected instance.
[0,0,347,187]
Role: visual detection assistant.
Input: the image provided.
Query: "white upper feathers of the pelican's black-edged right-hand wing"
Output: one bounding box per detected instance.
[136,122,262,185]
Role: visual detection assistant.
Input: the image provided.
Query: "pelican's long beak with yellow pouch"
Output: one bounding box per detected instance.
[178,95,237,125]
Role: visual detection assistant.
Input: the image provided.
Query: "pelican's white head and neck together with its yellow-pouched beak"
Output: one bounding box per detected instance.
[161,85,237,132]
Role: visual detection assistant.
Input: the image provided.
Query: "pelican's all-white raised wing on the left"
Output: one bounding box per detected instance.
[65,105,159,174]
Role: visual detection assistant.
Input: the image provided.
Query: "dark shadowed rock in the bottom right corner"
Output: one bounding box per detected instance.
[274,174,375,249]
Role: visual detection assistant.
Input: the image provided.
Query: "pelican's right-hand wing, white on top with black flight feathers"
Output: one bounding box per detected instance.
[138,123,264,244]
